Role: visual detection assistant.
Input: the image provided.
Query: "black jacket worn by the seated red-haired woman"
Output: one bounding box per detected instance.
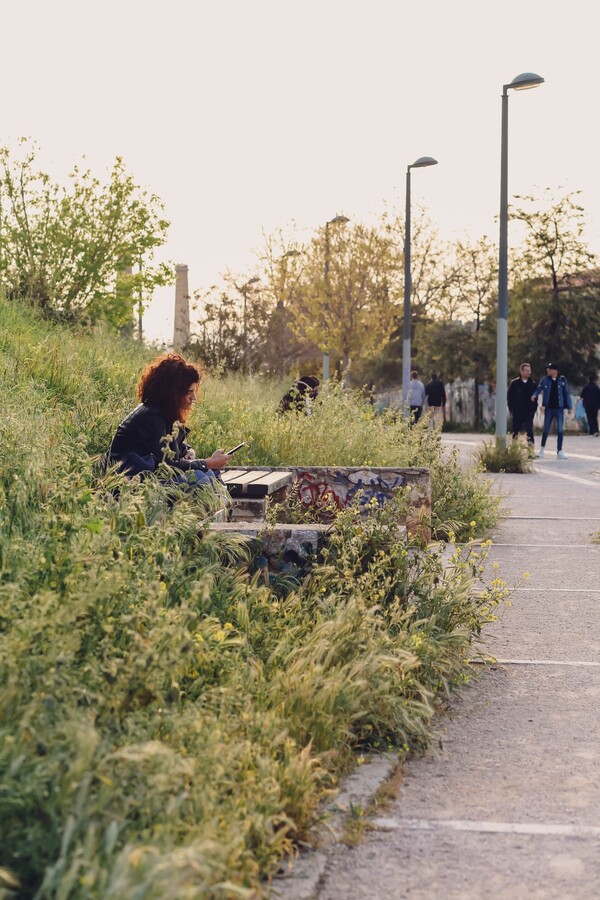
[106,403,207,472]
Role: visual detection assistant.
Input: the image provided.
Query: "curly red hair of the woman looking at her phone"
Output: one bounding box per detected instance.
[137,353,202,426]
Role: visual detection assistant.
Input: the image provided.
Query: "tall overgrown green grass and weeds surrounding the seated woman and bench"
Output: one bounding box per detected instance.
[0,301,504,900]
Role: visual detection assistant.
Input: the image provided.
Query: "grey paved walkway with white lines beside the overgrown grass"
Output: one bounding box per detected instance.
[315,435,600,900]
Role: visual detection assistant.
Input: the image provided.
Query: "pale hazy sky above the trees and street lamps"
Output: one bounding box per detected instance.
[0,0,600,340]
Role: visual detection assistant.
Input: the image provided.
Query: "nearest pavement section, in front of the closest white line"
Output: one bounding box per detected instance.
[319,829,600,900]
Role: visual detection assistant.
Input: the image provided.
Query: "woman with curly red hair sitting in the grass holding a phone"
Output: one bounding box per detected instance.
[106,353,231,484]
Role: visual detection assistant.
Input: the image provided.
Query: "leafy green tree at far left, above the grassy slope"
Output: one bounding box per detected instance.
[0,139,172,326]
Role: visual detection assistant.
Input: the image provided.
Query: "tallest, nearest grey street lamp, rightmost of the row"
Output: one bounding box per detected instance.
[496,72,544,447]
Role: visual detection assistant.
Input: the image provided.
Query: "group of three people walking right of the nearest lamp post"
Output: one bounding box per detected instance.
[507,362,600,459]
